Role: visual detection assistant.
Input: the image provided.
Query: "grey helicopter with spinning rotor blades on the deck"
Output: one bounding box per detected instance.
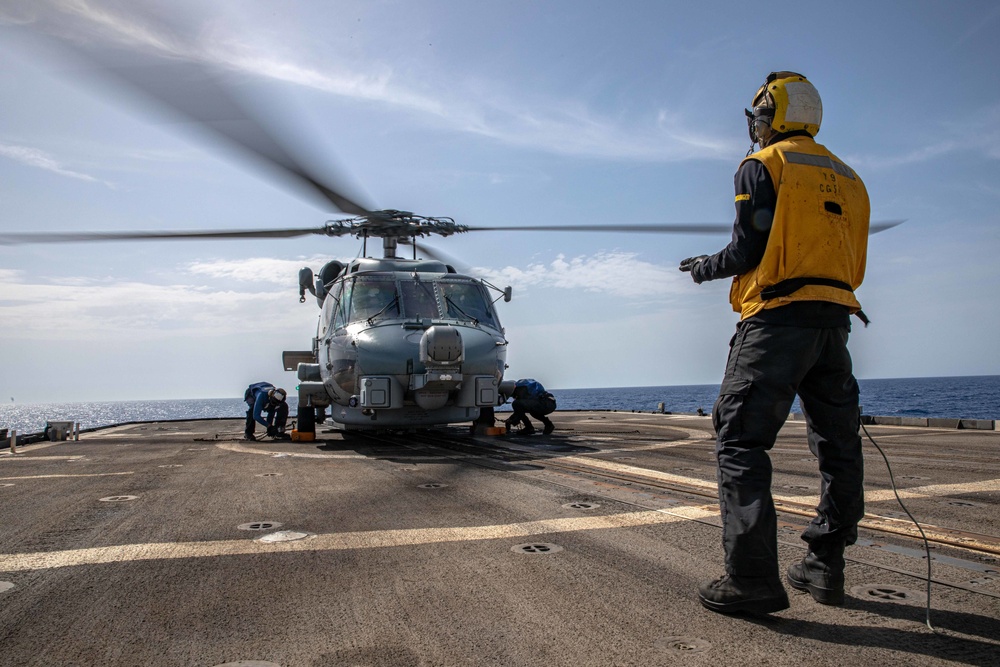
[0,10,904,433]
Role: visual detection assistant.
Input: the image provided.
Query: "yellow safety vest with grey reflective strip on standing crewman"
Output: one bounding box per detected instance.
[729,136,870,319]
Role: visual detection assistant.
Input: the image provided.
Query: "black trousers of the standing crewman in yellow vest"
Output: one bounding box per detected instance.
[712,321,864,577]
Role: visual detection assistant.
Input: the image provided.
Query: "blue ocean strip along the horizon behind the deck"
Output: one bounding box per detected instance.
[0,375,1000,434]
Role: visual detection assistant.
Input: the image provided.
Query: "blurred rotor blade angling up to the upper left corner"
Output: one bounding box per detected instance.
[19,9,376,216]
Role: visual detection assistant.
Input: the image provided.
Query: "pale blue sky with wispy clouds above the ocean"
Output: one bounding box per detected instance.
[0,0,1000,403]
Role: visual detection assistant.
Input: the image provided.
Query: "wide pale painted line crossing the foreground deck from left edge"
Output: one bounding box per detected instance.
[0,507,718,572]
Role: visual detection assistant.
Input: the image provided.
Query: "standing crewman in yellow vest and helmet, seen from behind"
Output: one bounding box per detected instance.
[680,72,869,613]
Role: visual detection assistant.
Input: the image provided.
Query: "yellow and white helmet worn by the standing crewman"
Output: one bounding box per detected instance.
[744,72,823,151]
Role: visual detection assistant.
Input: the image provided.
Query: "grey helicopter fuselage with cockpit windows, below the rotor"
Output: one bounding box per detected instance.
[286,258,507,430]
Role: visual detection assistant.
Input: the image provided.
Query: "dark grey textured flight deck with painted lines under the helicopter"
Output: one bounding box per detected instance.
[0,411,1000,667]
